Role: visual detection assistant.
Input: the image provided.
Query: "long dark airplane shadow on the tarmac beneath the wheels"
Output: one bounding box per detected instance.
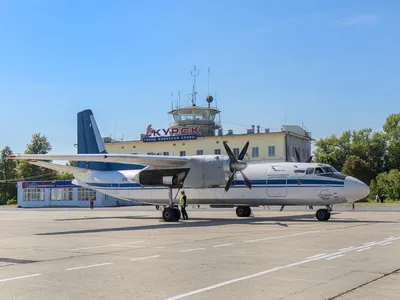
[36,213,399,235]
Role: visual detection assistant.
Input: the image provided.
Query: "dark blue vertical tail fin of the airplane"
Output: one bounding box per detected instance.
[77,109,110,171]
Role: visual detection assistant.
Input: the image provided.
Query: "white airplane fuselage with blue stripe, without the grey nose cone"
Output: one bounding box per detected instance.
[72,163,347,206]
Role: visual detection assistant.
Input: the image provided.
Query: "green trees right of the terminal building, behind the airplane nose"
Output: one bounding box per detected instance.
[314,113,400,201]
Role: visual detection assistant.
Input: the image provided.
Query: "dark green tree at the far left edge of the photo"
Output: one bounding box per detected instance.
[0,146,17,204]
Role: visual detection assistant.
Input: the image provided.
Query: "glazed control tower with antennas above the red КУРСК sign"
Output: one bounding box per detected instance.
[168,66,222,136]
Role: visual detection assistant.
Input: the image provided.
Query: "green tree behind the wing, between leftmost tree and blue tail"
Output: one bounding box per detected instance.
[17,133,57,180]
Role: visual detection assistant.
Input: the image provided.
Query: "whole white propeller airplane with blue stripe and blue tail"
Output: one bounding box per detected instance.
[8,109,370,222]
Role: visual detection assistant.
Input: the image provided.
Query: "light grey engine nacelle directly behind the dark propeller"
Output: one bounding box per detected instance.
[183,155,231,188]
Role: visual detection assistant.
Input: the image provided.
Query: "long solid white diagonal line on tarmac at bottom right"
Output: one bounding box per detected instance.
[165,237,400,300]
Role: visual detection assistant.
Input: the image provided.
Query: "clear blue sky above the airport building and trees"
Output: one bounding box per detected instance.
[0,0,400,153]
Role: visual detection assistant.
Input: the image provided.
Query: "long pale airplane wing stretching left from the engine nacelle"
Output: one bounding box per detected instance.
[7,153,190,167]
